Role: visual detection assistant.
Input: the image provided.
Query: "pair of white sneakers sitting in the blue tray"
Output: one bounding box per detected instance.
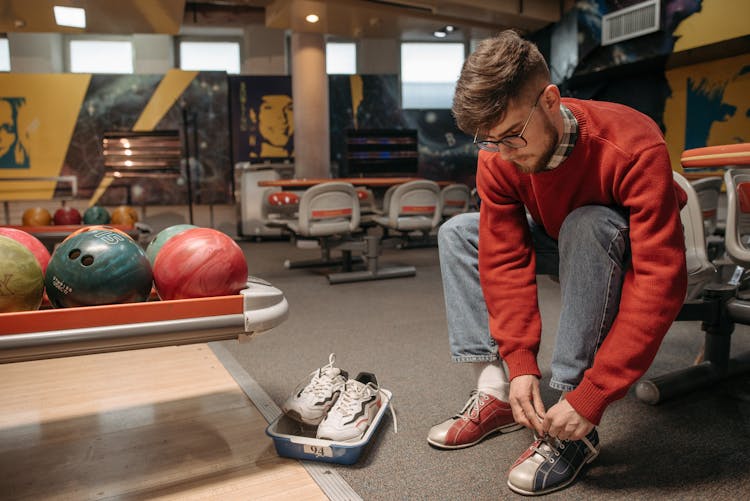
[281,353,383,442]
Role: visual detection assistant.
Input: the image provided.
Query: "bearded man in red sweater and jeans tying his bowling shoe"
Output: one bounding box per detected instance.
[428,31,687,495]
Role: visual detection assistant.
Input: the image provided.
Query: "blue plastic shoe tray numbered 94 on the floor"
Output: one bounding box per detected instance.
[266,388,393,464]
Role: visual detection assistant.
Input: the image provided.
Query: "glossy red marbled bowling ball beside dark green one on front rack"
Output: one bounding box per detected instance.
[154,228,247,299]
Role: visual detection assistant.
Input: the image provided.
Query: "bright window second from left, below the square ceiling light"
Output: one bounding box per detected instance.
[69,40,133,73]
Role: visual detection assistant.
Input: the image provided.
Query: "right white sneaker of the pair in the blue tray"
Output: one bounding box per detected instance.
[317,372,383,442]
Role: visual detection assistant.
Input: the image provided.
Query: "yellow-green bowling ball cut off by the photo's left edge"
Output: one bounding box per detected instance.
[0,232,44,313]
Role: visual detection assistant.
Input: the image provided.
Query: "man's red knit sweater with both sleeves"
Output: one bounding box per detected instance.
[477,98,687,424]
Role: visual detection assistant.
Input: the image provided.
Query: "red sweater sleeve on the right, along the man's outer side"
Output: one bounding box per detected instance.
[566,144,687,424]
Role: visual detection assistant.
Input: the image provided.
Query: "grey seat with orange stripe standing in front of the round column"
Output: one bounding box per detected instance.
[284,181,359,269]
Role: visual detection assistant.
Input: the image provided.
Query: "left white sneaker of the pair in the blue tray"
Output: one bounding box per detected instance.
[281,353,349,426]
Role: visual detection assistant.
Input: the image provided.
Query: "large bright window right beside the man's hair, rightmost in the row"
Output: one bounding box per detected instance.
[401,43,464,109]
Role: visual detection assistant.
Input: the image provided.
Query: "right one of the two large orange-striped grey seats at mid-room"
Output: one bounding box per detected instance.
[374,179,442,247]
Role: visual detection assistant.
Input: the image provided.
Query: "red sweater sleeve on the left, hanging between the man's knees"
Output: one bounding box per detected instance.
[477,154,541,379]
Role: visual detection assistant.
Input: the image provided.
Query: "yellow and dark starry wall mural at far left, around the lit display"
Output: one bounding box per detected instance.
[0,70,232,205]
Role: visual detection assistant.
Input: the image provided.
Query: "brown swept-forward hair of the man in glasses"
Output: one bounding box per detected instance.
[453,30,550,135]
